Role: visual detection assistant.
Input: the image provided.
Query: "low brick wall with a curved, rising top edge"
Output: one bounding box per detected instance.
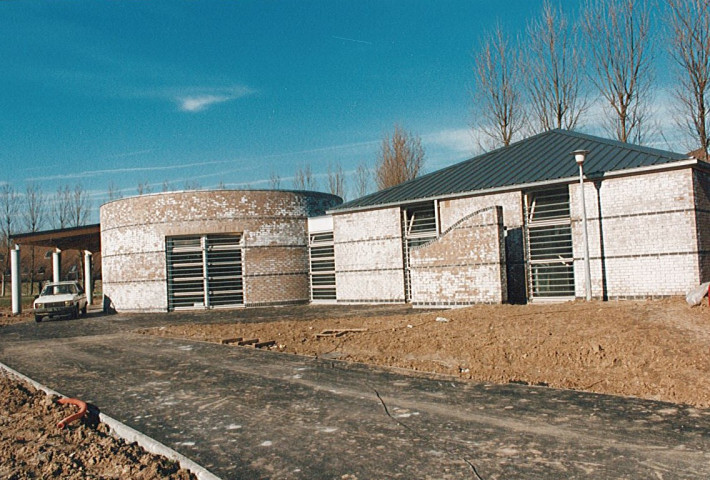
[410,206,507,305]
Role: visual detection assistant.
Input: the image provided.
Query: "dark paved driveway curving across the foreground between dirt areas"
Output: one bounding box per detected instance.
[0,307,710,480]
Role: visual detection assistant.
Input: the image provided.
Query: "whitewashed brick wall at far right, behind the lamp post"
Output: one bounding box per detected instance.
[569,169,700,299]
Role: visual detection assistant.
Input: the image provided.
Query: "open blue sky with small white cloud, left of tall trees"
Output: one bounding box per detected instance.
[0,0,680,221]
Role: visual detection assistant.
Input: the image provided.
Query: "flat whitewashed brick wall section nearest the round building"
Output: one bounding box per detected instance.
[333,207,404,303]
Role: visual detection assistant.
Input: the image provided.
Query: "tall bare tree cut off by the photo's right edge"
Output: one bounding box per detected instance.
[668,0,710,159]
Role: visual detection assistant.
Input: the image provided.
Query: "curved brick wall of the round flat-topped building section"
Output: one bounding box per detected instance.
[100,190,341,311]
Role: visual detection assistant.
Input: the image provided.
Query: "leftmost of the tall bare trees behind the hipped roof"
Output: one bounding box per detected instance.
[473,25,525,149]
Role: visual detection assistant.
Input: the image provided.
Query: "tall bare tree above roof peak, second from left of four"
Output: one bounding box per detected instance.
[521,0,587,131]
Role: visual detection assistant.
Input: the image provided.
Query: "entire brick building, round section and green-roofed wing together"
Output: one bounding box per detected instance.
[15,130,710,310]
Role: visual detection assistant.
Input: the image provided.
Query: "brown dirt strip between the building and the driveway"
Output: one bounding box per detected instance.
[141,298,710,408]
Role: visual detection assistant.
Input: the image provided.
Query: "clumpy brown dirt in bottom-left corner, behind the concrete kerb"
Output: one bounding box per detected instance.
[0,371,197,480]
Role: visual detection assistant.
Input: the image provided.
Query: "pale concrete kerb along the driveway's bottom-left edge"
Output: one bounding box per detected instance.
[0,362,221,480]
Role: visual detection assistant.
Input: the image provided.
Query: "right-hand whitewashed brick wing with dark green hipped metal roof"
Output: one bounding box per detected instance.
[329,130,710,305]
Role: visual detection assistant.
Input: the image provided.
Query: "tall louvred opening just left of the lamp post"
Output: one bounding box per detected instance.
[525,186,574,301]
